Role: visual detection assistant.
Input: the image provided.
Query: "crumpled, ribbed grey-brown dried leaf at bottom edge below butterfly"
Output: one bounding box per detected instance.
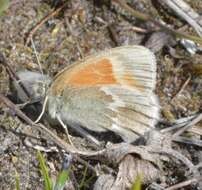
[94,155,160,190]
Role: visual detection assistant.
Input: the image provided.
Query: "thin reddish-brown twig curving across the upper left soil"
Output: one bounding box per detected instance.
[25,1,68,45]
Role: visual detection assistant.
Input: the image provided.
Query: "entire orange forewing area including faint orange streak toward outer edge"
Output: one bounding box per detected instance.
[51,58,144,95]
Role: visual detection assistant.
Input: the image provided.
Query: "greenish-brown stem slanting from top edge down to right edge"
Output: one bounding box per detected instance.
[112,0,202,44]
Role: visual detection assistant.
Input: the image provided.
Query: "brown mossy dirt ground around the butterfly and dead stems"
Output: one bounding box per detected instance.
[0,0,202,190]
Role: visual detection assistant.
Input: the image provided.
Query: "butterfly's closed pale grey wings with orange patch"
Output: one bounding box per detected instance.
[48,46,159,141]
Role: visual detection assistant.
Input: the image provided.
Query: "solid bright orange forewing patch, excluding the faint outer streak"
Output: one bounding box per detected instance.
[52,58,119,94]
